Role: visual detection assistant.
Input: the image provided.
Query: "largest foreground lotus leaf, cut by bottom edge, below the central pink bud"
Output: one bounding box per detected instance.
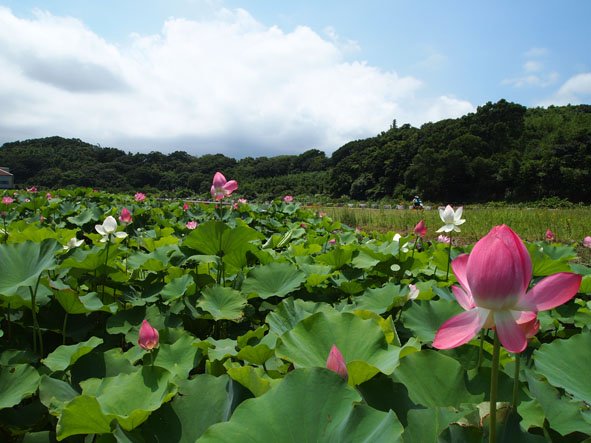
[197,368,402,443]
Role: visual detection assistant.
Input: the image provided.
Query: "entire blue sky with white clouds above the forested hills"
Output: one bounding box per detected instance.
[0,0,591,157]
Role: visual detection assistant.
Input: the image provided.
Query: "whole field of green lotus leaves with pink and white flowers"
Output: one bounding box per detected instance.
[0,178,591,443]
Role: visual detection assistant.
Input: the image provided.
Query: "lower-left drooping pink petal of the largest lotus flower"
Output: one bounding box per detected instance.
[433,308,490,349]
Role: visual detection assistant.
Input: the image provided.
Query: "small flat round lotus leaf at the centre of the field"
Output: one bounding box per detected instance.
[242,262,306,299]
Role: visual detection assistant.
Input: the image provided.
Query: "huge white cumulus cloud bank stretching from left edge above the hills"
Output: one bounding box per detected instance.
[0,7,474,157]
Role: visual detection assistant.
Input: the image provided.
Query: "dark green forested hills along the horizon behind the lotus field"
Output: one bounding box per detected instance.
[0,100,591,203]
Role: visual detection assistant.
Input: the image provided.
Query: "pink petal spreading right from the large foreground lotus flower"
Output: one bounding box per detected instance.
[515,272,583,311]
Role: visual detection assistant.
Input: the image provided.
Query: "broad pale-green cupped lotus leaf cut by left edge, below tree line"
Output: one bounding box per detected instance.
[0,239,59,296]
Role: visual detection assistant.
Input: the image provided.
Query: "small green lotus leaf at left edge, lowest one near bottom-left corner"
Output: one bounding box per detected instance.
[0,364,40,409]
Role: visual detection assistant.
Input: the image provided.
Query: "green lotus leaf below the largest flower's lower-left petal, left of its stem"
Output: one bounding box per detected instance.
[393,350,484,407]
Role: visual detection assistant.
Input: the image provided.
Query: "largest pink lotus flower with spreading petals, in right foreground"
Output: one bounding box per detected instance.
[433,225,582,353]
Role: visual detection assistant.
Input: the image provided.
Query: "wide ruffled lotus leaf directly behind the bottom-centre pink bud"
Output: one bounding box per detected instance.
[276,312,400,384]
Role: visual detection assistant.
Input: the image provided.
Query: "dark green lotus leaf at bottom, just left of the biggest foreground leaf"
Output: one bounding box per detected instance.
[141,374,239,443]
